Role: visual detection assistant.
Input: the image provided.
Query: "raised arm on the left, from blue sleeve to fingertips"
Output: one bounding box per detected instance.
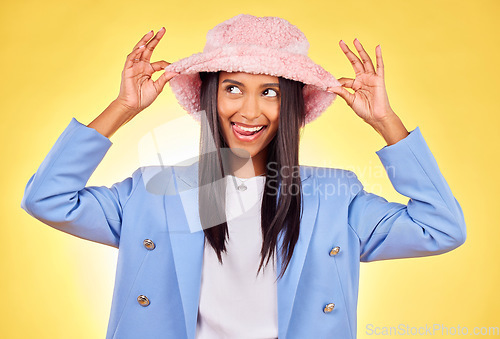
[21,29,176,247]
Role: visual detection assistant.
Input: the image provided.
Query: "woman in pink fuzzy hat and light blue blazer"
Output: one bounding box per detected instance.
[22,15,466,338]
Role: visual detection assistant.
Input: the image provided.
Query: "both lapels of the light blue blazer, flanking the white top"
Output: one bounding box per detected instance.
[164,162,319,339]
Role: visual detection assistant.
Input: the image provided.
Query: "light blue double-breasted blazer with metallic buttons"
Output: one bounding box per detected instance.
[21,119,466,339]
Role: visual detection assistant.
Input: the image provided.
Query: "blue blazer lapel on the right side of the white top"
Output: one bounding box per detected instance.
[276,166,319,338]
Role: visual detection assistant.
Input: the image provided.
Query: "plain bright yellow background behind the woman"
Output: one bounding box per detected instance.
[0,0,500,339]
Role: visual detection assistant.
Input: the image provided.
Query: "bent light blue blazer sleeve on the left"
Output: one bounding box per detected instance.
[21,118,141,247]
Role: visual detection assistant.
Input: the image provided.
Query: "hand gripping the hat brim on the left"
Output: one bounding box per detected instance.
[115,27,178,118]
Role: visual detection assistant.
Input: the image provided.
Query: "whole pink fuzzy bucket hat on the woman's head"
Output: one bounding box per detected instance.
[165,14,340,123]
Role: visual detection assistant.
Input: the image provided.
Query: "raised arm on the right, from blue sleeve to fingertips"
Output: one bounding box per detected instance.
[328,39,466,261]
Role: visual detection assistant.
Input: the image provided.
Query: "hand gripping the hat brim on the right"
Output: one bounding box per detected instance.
[327,39,394,126]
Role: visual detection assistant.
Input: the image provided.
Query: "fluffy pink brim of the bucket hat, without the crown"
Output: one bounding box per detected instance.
[165,45,340,123]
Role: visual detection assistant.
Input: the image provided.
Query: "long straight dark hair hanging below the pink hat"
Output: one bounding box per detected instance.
[198,72,305,278]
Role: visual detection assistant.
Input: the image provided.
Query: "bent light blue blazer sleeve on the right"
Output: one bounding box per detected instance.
[348,127,466,261]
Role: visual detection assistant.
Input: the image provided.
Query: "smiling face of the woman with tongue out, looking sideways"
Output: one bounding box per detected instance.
[217,72,281,165]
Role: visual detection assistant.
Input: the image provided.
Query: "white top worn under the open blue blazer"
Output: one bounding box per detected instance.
[196,175,278,339]
